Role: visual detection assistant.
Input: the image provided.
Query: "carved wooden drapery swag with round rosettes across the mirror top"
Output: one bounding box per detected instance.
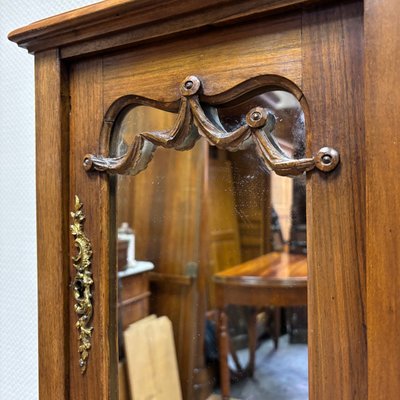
[83,76,340,176]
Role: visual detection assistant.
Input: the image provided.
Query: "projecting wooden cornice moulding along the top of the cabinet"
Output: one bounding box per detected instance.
[8,0,328,58]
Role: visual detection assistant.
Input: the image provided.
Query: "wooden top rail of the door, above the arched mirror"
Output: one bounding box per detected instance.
[104,16,301,105]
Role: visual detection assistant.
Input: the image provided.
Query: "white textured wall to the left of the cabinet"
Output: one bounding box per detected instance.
[0,0,95,400]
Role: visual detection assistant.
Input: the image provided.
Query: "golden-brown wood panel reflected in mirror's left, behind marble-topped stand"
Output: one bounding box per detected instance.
[117,107,204,275]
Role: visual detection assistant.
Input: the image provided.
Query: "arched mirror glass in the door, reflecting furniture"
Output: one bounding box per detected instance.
[112,91,308,400]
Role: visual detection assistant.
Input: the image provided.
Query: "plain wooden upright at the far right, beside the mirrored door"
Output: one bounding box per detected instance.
[364,0,400,399]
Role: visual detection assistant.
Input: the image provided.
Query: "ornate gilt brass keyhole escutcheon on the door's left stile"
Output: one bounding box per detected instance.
[71,196,93,374]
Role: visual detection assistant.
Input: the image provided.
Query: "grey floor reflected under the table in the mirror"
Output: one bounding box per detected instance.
[212,335,308,400]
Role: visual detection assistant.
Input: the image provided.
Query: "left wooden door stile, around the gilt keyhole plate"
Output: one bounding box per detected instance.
[69,59,118,400]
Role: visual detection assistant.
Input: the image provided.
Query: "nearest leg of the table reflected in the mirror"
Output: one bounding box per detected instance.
[218,309,230,400]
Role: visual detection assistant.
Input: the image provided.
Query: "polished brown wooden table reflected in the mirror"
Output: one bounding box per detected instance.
[213,252,307,400]
